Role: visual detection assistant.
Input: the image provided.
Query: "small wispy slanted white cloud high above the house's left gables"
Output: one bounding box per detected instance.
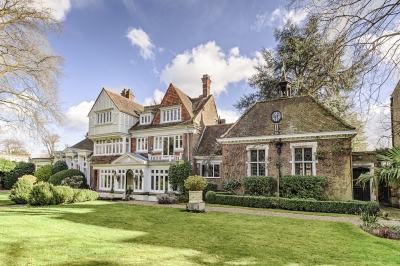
[126,28,155,60]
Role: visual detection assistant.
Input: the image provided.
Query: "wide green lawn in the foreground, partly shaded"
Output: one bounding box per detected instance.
[0,201,400,266]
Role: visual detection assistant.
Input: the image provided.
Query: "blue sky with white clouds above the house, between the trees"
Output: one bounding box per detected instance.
[25,0,394,156]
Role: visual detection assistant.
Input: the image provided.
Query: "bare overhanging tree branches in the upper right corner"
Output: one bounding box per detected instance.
[289,0,400,106]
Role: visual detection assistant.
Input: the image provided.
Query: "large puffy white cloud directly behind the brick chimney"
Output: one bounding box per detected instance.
[160,42,261,97]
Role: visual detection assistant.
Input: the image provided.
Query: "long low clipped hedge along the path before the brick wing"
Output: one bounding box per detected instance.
[206,191,379,214]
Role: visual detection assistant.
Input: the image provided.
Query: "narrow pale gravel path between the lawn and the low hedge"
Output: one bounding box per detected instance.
[118,200,400,226]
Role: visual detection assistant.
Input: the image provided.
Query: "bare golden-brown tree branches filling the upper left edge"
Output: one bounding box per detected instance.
[0,0,63,132]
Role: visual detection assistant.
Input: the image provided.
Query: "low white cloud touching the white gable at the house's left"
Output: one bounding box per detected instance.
[65,101,94,132]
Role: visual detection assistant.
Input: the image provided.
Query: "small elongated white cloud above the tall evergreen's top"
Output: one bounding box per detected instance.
[251,8,307,32]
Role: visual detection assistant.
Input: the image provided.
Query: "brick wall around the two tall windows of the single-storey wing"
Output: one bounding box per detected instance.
[221,139,353,200]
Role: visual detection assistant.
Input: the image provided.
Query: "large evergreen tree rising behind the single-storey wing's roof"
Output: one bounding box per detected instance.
[234,17,363,115]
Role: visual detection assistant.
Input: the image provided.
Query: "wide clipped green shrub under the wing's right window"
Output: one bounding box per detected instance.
[279,175,328,200]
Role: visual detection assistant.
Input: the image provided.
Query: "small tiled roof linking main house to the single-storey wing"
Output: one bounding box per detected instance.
[195,124,232,156]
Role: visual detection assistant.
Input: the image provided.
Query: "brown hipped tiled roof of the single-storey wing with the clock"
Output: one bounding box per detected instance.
[222,95,355,138]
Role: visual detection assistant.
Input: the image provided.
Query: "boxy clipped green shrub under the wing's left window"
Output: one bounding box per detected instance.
[242,176,273,197]
